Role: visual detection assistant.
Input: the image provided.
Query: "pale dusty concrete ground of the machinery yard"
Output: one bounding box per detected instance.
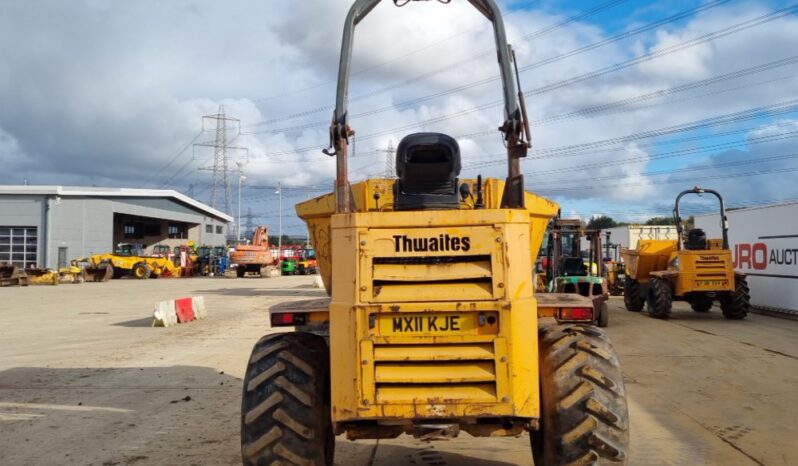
[0,277,798,466]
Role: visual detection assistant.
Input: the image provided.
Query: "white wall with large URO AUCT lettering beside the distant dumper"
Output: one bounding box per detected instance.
[695,201,798,315]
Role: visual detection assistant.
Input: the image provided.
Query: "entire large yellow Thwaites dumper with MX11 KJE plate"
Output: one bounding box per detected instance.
[241,0,629,465]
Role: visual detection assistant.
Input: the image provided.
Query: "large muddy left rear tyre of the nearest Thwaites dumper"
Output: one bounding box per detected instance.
[241,332,335,466]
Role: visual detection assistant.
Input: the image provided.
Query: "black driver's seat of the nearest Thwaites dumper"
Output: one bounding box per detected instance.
[394,133,461,210]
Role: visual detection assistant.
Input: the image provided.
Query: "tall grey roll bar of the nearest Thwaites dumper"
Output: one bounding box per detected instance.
[324,0,529,212]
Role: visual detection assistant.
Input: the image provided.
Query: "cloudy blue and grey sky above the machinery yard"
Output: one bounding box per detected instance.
[0,0,798,234]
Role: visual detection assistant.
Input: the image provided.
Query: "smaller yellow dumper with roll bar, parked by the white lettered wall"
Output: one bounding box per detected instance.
[621,187,751,320]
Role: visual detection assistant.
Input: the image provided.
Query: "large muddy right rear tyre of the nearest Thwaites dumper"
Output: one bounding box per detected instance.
[531,325,629,466]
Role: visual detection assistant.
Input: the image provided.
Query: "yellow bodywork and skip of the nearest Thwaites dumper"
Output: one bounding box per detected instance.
[296,179,558,430]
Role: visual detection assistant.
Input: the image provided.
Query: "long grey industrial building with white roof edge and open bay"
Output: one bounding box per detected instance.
[0,186,233,268]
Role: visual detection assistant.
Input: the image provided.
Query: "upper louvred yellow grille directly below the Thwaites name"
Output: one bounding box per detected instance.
[372,255,493,302]
